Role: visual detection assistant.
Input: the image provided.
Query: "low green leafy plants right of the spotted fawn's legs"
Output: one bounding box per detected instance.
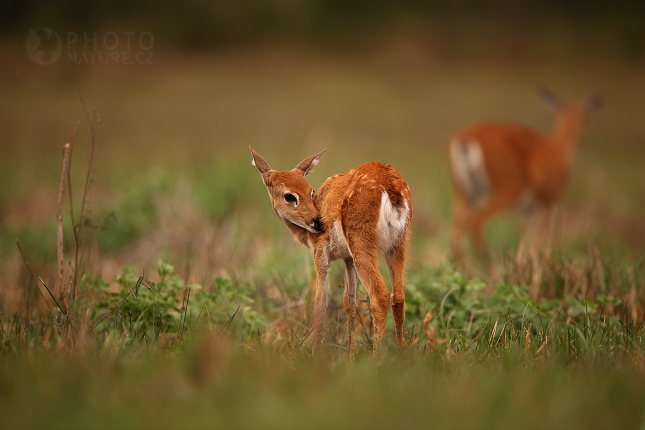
[406,271,622,346]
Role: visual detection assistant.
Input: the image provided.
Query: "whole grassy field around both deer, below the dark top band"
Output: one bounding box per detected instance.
[0,45,645,429]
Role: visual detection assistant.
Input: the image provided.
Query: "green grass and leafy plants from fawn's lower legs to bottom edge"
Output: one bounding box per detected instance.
[0,262,645,429]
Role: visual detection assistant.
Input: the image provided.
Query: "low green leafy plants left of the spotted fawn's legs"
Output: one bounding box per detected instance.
[90,260,267,340]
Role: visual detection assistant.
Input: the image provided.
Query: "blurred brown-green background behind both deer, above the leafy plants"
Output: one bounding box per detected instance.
[0,0,645,288]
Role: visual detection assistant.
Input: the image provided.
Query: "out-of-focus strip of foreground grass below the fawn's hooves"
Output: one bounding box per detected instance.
[3,350,645,429]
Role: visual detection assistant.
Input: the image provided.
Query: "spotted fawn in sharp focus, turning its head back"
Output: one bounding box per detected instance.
[249,147,412,350]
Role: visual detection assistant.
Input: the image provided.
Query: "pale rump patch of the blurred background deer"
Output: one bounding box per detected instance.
[450,140,490,206]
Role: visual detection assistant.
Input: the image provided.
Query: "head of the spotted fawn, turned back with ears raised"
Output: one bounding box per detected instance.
[249,146,325,233]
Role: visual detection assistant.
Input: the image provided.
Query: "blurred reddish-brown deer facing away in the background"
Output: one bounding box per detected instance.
[449,89,602,261]
